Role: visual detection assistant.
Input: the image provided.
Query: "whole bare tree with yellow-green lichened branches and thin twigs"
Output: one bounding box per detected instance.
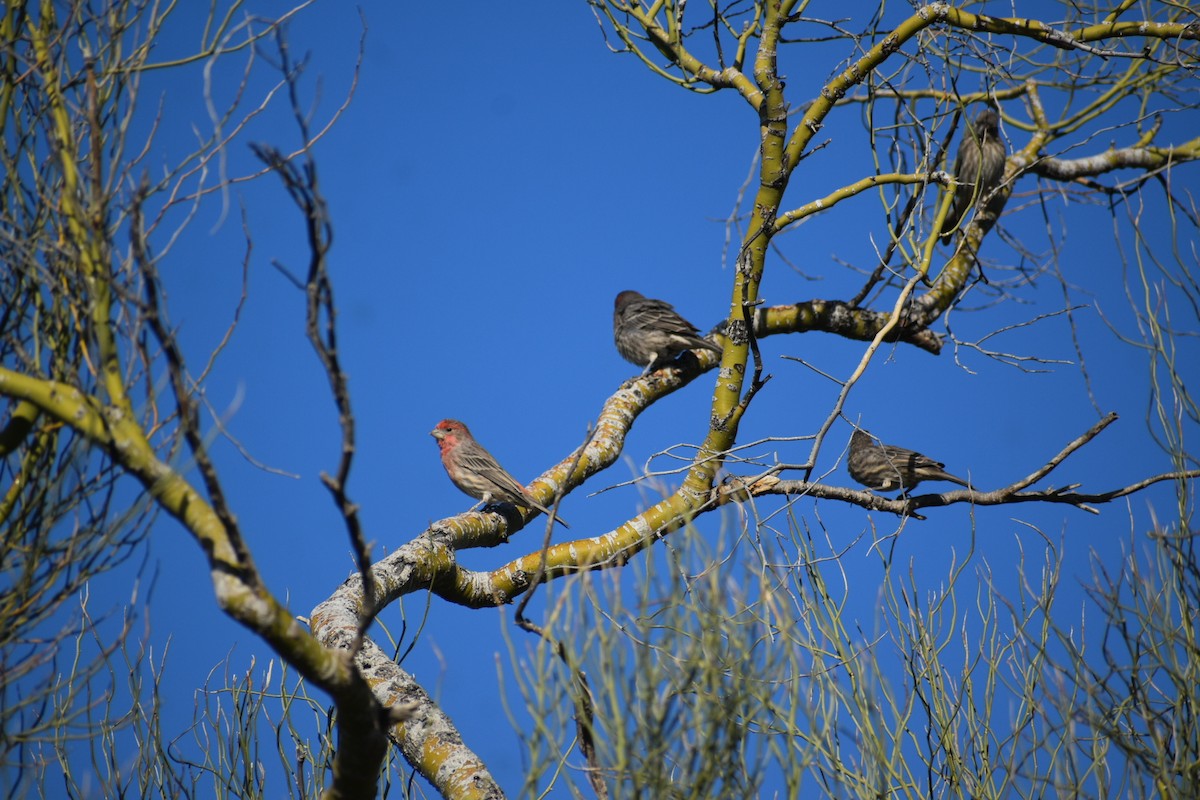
[0,0,1200,798]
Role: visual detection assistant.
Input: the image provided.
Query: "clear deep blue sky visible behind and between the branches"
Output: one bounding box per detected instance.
[51,0,1196,788]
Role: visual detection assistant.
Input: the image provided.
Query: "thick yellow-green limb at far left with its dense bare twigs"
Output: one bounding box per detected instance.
[0,2,398,796]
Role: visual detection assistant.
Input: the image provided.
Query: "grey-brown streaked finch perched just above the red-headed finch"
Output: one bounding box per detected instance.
[612,290,721,375]
